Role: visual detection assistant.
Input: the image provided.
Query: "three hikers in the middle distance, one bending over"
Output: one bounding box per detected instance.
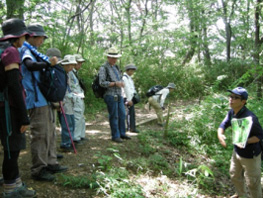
[99,47,175,143]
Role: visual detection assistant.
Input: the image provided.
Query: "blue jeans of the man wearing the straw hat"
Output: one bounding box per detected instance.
[104,95,125,139]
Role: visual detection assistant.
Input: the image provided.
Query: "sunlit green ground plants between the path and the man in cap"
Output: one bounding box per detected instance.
[56,92,263,198]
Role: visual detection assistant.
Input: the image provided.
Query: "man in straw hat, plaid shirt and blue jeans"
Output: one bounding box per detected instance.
[99,47,131,143]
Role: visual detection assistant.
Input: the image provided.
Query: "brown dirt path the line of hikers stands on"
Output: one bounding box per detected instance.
[0,100,198,198]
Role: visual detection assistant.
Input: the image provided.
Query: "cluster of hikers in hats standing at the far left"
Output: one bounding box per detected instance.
[0,18,86,198]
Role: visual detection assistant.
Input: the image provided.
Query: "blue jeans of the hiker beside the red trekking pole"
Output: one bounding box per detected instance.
[59,113,75,147]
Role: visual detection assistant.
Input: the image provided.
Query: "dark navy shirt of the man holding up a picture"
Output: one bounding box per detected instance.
[219,106,263,158]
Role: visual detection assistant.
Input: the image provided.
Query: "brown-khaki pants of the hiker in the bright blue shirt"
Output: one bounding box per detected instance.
[29,106,57,175]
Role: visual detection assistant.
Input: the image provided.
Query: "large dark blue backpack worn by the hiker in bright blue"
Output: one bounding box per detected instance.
[38,65,67,102]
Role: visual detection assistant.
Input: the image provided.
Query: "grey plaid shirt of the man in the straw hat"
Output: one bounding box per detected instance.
[99,62,123,96]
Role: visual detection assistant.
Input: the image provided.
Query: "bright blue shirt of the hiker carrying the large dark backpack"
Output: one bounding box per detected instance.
[20,45,48,109]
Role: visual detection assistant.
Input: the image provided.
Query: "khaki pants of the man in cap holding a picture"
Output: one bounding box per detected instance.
[229,151,262,198]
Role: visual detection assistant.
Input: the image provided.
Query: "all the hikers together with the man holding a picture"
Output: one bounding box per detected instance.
[0,19,263,198]
